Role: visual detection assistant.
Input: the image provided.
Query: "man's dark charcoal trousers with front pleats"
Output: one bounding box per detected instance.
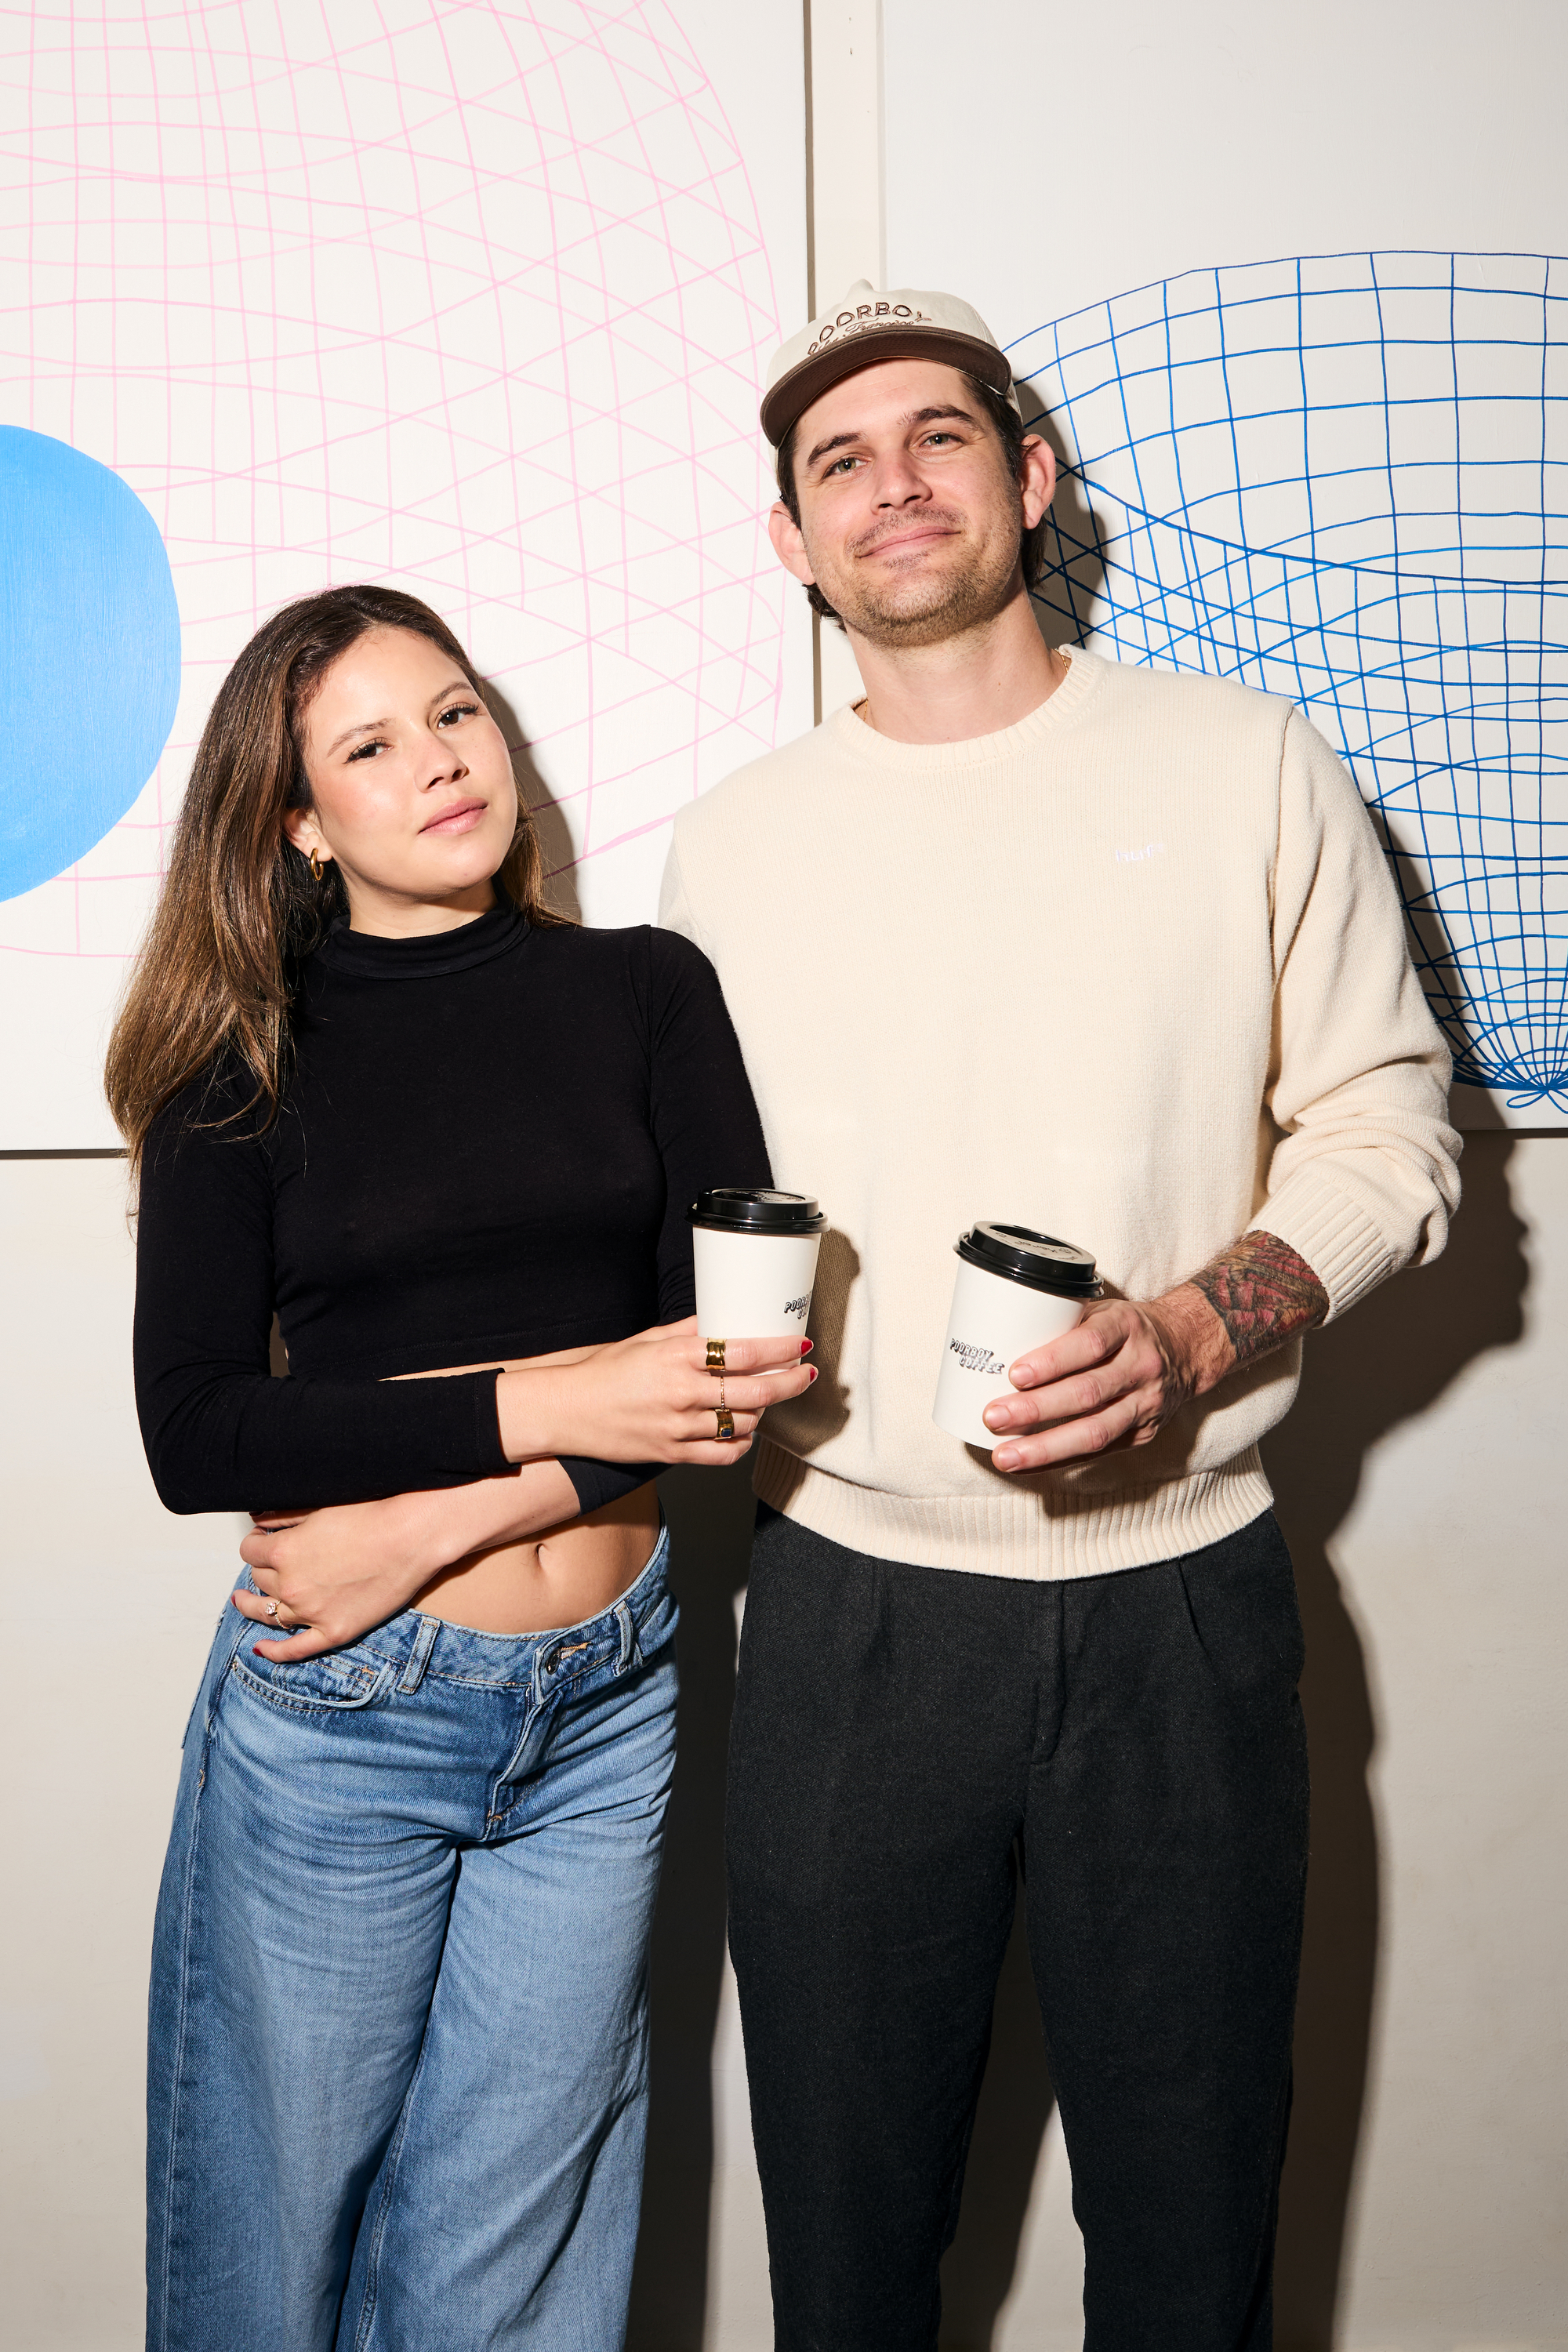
[729,1508,1307,2352]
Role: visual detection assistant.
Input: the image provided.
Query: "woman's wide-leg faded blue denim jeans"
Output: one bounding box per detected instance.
[148,1534,677,2352]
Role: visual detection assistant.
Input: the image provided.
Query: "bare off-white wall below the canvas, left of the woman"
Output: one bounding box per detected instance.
[0,1160,251,2352]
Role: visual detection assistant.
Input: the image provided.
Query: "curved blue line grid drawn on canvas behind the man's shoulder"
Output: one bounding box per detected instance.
[1011,252,1568,1112]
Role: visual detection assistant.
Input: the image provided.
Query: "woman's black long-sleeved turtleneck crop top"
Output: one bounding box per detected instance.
[136,903,771,1510]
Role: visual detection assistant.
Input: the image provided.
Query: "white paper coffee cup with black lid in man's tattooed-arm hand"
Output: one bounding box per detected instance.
[931,1223,1102,1454]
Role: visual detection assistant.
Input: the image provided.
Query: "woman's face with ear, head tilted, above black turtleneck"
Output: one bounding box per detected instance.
[285,628,517,931]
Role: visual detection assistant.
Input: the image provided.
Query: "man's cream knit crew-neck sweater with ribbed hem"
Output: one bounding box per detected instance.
[661,652,1460,1576]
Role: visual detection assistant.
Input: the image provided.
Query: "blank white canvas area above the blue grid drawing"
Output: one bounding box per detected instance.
[881,0,1568,358]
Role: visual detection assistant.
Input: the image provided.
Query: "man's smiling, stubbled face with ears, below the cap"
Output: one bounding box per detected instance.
[769,360,1055,647]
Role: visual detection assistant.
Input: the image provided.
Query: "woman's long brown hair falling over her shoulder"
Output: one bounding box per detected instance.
[103,588,569,1178]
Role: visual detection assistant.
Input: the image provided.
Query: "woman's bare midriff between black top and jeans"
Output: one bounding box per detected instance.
[402,1348,659,1635]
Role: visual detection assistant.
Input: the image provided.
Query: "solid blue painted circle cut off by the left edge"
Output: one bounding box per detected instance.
[0,426,179,898]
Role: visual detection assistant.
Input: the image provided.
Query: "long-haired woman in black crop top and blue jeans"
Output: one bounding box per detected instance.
[108,588,813,2352]
